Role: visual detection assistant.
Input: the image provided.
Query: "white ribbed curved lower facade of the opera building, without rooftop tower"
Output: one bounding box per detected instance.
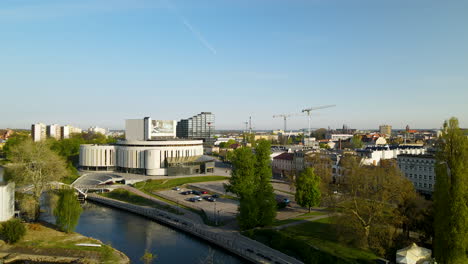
[79,140,203,176]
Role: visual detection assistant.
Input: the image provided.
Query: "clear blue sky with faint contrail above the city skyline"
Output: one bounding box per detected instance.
[0,0,468,129]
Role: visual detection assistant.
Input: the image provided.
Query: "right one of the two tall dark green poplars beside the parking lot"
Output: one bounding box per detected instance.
[254,139,277,226]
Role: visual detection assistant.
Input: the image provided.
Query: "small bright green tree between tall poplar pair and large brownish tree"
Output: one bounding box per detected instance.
[295,168,322,212]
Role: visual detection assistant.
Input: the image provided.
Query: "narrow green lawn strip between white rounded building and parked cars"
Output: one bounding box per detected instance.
[135,176,229,192]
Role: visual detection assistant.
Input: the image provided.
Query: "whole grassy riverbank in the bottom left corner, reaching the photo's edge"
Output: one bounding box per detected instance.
[0,223,130,264]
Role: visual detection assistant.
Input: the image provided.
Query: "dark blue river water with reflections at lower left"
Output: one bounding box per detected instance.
[71,202,244,264]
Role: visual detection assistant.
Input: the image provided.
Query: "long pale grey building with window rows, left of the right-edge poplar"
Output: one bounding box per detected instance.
[397,154,436,194]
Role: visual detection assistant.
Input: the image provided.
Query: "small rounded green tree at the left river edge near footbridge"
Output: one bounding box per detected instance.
[54,189,83,233]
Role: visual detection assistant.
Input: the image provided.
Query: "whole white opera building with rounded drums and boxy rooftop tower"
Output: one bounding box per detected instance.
[79,117,214,176]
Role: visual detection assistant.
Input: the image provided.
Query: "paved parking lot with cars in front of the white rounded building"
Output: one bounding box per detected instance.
[157,188,239,223]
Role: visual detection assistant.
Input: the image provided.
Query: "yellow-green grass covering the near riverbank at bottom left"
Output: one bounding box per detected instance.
[12,223,121,263]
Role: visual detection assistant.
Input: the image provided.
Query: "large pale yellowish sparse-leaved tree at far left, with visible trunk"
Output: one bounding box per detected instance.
[7,140,67,219]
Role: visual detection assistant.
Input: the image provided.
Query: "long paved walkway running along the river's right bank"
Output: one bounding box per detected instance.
[87,194,302,264]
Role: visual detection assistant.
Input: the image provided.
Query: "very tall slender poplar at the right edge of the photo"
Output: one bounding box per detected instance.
[434,118,468,264]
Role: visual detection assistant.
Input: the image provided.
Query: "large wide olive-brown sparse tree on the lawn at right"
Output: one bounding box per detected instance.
[338,157,414,255]
